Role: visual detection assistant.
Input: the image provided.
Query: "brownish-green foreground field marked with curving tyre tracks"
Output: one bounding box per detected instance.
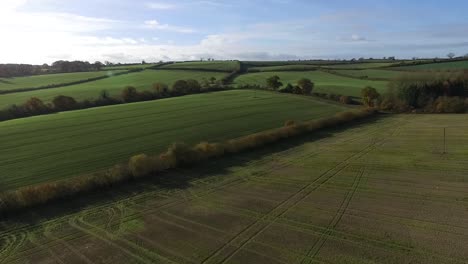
[0,115,468,264]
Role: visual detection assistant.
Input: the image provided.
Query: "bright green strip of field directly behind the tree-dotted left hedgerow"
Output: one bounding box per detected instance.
[0,70,228,108]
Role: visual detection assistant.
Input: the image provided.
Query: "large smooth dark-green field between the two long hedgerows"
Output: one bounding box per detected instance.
[0,90,348,191]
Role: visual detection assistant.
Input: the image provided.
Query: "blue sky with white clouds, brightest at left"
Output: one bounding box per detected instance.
[0,0,468,64]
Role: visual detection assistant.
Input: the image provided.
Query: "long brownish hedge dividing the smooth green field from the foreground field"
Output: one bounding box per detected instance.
[0,110,375,213]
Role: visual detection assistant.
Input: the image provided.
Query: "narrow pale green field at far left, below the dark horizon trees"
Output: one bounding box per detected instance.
[0,71,119,91]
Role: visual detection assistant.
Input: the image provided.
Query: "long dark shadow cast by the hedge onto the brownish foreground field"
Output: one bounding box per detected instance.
[0,114,389,226]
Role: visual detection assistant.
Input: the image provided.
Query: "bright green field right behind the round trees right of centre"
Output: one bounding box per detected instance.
[234,71,387,96]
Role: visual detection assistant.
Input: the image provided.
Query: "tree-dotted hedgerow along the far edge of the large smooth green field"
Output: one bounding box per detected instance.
[0,80,229,121]
